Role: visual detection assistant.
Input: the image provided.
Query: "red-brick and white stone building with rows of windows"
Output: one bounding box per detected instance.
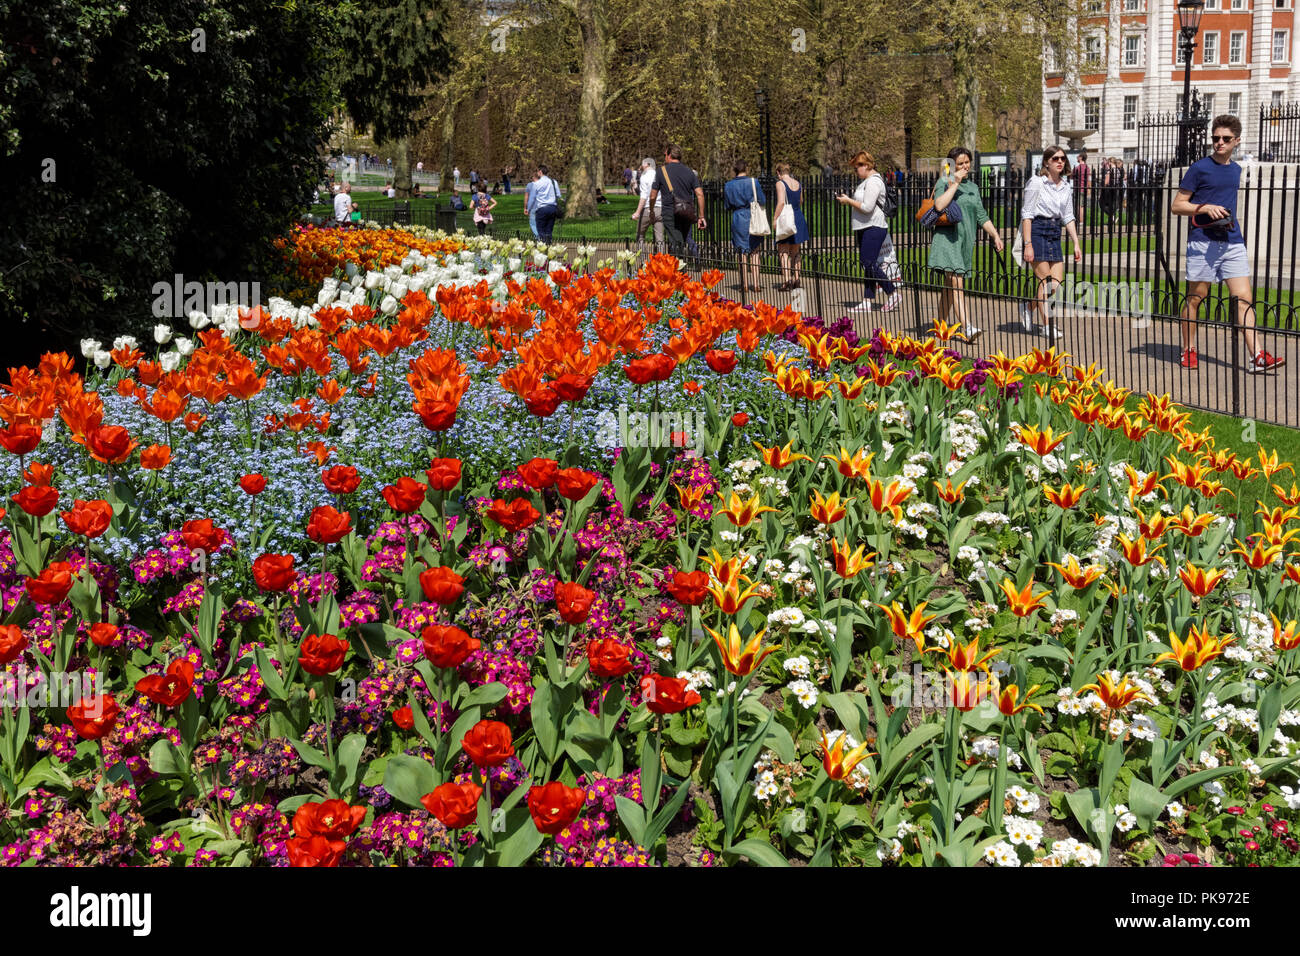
[1043,0,1300,161]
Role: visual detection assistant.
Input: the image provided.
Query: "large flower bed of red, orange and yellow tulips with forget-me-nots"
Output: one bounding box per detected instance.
[0,230,1300,866]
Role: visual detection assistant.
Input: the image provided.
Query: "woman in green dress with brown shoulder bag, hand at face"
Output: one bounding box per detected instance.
[930,146,1002,342]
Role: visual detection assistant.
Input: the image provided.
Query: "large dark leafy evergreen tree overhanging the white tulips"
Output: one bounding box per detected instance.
[0,0,335,358]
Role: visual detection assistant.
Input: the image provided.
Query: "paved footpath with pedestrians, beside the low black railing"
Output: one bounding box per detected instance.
[595,245,1300,428]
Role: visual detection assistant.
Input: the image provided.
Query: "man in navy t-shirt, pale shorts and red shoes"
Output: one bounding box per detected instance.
[1170,114,1286,372]
